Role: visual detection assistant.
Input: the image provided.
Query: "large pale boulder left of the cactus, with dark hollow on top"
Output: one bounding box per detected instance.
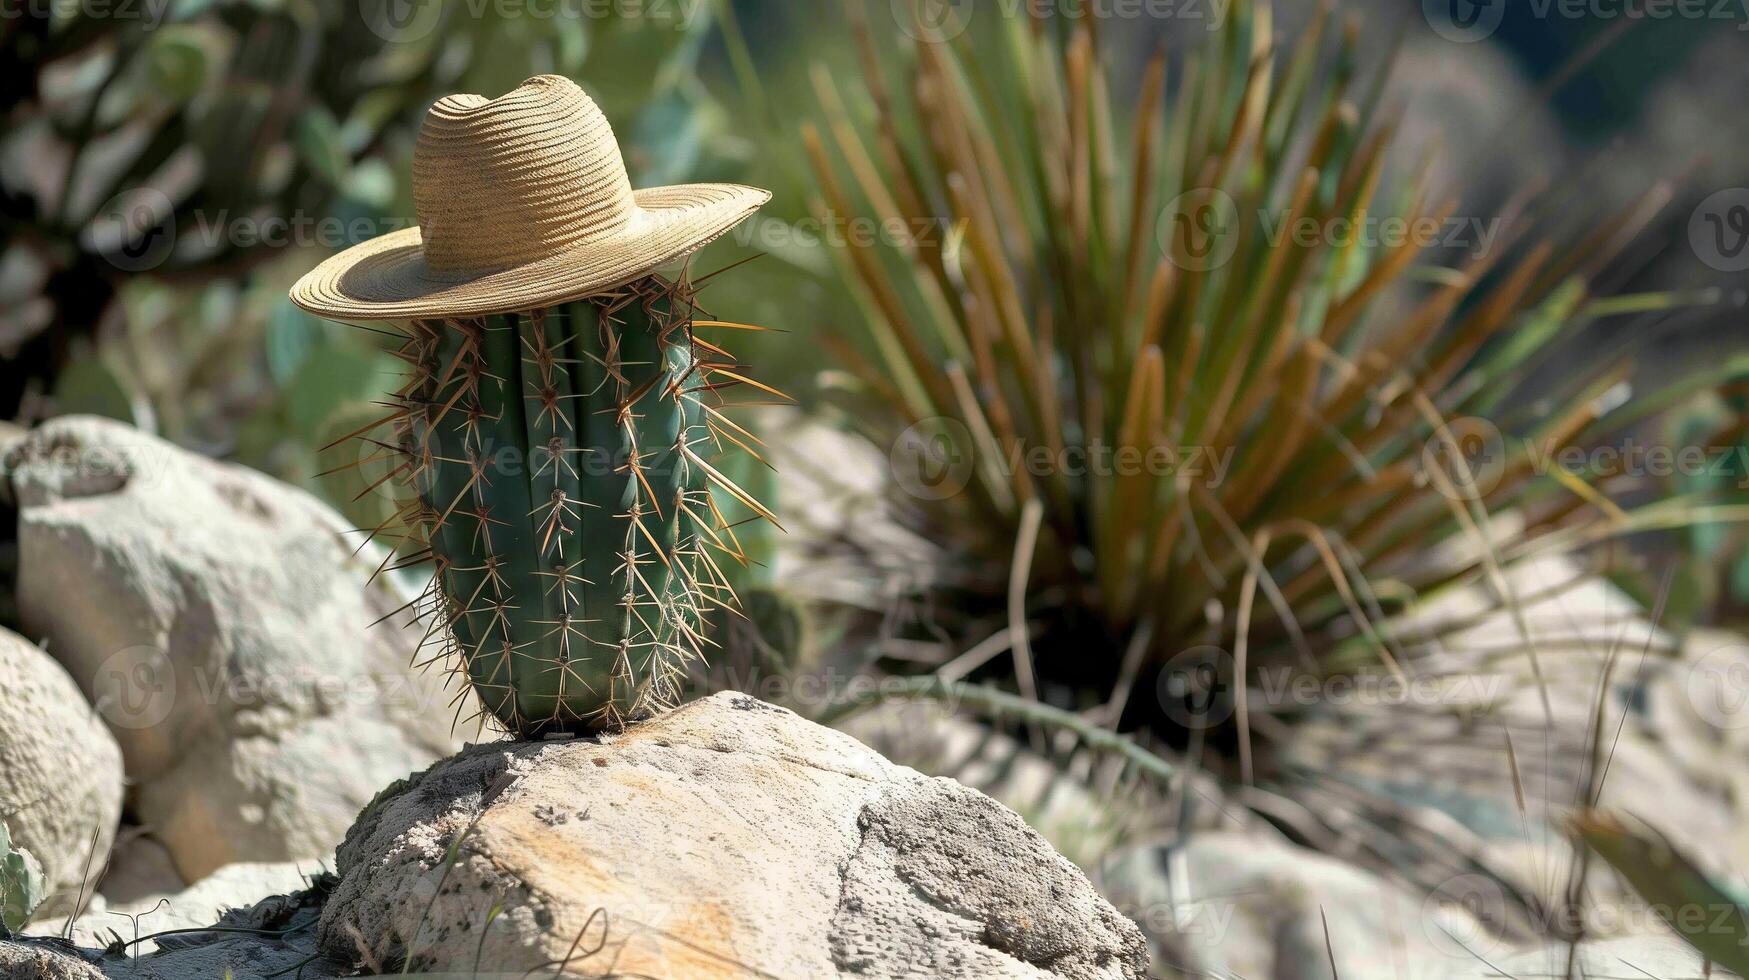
[3,417,455,880]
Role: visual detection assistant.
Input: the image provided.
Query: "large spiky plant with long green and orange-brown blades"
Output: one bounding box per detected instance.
[803,2,1749,733]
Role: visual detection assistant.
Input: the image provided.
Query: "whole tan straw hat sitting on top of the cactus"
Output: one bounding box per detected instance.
[292,75,771,320]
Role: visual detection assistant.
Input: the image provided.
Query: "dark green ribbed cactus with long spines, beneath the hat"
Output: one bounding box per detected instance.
[392,277,771,737]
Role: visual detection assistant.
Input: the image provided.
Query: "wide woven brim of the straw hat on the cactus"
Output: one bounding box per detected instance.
[292,184,771,320]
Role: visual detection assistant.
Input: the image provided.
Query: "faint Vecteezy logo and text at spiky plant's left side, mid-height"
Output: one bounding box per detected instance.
[887,417,1237,501]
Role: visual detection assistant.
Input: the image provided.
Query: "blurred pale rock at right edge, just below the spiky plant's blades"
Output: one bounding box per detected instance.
[1254,557,1749,938]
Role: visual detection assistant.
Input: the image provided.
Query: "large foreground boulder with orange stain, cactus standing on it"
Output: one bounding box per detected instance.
[320,695,1147,980]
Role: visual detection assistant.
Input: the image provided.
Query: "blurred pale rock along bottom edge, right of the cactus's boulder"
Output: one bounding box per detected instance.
[1098,833,1732,980]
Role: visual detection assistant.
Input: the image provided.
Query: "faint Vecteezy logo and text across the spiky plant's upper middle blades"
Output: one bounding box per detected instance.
[1154,187,1504,271]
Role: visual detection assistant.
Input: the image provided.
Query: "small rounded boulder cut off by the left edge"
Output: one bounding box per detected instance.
[0,630,122,914]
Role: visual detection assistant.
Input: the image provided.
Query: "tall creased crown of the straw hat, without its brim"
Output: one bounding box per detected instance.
[413,75,637,278]
